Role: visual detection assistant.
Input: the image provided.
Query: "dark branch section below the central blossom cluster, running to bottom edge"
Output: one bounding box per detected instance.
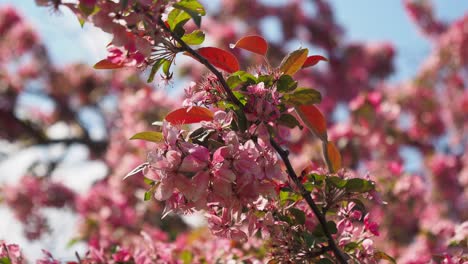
[270,138,347,264]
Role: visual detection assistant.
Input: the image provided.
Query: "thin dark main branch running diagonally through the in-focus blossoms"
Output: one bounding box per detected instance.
[158,18,347,264]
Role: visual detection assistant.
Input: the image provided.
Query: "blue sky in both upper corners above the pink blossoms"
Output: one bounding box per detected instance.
[0,0,468,80]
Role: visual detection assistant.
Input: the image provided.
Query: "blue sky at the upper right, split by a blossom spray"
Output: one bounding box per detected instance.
[331,0,468,80]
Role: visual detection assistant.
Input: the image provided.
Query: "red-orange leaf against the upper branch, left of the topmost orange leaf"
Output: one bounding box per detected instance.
[198,47,240,73]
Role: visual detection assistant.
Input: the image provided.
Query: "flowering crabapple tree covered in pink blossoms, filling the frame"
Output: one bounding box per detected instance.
[0,0,468,263]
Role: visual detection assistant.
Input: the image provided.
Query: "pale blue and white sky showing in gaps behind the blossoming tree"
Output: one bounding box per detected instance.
[0,0,468,257]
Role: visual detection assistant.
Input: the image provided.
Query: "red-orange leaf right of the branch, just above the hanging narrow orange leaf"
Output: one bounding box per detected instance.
[296,105,328,141]
